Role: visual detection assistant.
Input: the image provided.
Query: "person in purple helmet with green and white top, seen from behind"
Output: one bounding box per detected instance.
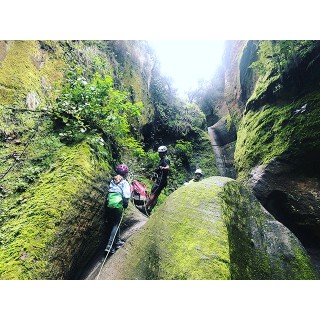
[105,164,131,253]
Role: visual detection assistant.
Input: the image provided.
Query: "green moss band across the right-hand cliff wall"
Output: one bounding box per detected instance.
[235,92,320,178]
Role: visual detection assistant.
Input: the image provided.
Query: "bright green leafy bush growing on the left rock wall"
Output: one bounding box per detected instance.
[52,67,142,150]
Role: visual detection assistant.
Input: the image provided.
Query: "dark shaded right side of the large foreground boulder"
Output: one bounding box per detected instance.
[222,181,316,280]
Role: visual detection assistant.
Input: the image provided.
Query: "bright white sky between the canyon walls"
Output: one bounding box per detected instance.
[148,40,224,97]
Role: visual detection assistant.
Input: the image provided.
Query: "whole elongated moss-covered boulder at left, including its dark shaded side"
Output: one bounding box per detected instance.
[0,143,112,279]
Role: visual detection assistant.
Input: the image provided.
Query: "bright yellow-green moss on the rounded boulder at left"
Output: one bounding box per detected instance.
[0,144,106,279]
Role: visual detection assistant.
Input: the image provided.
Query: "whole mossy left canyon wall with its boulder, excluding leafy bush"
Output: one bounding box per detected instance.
[0,40,160,279]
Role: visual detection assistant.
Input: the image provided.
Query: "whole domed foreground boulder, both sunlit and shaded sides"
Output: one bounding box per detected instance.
[103,177,317,279]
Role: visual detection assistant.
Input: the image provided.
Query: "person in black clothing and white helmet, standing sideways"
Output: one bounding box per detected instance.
[146,146,170,213]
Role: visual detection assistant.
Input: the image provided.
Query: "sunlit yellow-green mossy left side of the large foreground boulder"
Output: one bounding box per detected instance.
[117,177,230,279]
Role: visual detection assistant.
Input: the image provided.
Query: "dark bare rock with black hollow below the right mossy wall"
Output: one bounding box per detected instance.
[249,159,320,262]
